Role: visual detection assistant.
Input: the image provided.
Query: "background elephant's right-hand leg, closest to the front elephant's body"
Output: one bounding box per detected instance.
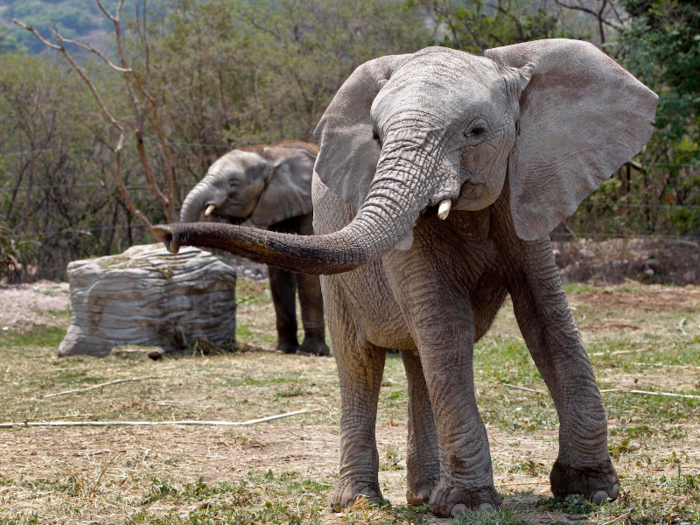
[296,273,330,355]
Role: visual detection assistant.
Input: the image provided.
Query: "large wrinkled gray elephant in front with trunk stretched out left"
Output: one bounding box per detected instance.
[158,40,657,516]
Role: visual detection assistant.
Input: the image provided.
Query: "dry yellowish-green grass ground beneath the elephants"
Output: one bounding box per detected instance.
[0,281,700,524]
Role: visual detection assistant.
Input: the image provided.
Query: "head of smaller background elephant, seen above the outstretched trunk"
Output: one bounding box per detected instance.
[180,141,318,227]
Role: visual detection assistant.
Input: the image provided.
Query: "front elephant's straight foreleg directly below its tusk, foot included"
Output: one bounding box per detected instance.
[386,246,501,516]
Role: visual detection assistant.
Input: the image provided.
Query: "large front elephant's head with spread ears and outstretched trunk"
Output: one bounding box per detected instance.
[157,39,658,274]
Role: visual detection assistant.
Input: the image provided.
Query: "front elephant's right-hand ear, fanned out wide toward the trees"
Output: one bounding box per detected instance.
[485,39,658,240]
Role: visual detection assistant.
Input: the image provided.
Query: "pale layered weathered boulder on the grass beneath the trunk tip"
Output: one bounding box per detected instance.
[58,244,236,357]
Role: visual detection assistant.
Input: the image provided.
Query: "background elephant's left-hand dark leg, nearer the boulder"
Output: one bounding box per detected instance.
[268,266,299,354]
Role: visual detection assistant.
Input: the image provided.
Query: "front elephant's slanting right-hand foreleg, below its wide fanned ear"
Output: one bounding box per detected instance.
[509,240,619,503]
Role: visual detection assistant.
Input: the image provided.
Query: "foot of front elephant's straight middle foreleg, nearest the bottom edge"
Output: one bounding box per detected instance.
[430,479,501,518]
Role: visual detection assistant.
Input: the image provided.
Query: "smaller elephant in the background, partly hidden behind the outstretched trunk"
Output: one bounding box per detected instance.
[180,140,329,355]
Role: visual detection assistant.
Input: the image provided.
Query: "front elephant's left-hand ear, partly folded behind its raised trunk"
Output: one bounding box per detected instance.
[314,54,413,210]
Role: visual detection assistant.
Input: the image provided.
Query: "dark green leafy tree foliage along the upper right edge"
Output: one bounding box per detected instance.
[617,0,700,218]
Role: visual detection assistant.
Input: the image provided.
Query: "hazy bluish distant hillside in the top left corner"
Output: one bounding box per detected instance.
[0,0,117,53]
